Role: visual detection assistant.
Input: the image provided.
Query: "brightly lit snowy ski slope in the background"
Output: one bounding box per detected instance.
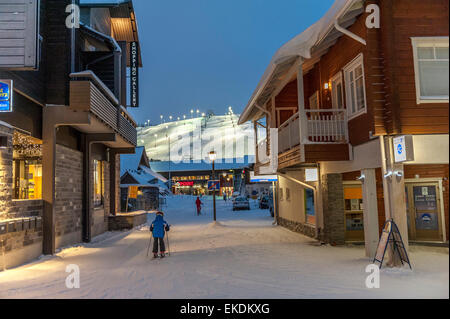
[138,114,255,162]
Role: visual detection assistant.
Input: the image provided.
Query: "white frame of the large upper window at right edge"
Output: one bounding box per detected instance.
[411,36,449,104]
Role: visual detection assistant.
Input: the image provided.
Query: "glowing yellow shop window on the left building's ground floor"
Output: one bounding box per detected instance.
[13,131,42,200]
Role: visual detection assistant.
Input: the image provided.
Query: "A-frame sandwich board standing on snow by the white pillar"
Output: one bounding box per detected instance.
[373,219,412,270]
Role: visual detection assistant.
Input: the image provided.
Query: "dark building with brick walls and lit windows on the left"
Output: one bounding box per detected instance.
[0,0,141,267]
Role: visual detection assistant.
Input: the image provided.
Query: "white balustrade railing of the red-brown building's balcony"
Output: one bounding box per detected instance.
[278,109,348,154]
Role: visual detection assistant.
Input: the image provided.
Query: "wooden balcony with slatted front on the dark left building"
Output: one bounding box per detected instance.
[70,71,137,147]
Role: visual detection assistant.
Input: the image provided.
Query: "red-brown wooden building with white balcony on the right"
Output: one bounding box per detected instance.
[240,0,450,257]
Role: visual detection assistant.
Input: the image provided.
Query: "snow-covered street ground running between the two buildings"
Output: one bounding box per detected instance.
[0,197,449,299]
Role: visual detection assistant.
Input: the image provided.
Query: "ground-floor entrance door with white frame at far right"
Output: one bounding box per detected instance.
[406,183,442,241]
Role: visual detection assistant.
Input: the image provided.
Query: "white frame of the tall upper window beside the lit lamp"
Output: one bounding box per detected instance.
[343,53,367,120]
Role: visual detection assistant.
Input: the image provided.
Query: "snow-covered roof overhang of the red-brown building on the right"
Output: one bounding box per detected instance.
[239,0,361,124]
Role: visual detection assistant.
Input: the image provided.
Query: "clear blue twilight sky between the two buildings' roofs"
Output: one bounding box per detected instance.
[126,0,334,124]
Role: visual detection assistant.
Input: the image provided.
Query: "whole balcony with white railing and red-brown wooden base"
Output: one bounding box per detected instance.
[278,109,349,169]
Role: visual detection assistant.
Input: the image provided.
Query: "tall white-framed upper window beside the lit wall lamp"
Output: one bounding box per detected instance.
[344,54,367,119]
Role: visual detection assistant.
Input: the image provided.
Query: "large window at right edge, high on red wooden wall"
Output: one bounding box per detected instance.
[412,37,449,104]
